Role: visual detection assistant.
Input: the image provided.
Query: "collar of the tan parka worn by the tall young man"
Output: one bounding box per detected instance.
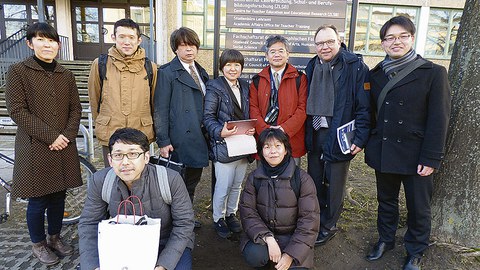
[108,45,145,73]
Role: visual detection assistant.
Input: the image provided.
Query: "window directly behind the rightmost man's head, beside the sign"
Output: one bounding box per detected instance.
[345,4,420,55]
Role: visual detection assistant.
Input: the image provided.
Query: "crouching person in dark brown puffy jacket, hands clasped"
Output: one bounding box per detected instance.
[239,128,320,270]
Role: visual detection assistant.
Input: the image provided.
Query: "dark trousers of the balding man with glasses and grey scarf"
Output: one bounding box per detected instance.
[307,129,350,232]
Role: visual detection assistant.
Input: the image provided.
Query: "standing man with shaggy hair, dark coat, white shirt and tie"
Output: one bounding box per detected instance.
[154,27,208,228]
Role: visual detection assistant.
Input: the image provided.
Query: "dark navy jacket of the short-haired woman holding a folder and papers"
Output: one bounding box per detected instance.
[203,76,250,160]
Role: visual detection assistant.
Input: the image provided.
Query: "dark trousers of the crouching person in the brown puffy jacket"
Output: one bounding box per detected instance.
[242,241,307,270]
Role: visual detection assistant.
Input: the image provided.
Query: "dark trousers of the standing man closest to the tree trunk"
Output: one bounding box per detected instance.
[375,171,433,255]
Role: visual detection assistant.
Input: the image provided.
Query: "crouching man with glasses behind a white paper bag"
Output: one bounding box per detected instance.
[78,128,194,270]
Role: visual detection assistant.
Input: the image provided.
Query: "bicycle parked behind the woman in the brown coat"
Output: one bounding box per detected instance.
[0,125,97,225]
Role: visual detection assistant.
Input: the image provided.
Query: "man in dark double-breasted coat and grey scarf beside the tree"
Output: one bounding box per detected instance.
[365,16,450,269]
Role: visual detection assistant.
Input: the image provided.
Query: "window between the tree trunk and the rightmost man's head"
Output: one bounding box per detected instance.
[425,8,462,58]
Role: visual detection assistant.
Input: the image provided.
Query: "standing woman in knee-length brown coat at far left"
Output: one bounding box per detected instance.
[5,23,82,265]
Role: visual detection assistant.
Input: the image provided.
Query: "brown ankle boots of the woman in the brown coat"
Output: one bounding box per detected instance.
[32,234,73,266]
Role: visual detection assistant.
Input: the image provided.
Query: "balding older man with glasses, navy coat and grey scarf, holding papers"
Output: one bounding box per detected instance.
[305,25,370,245]
